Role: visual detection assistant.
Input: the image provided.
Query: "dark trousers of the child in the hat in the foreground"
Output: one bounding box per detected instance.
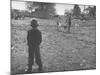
[28,46,42,68]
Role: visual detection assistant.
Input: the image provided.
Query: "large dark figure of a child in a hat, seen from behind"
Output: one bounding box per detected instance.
[27,20,42,72]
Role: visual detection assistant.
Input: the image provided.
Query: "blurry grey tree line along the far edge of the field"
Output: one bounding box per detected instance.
[11,2,96,18]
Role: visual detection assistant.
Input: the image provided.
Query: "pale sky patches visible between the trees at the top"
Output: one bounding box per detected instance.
[12,1,87,15]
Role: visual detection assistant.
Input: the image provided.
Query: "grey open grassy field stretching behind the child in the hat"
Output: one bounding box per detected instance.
[11,19,96,74]
